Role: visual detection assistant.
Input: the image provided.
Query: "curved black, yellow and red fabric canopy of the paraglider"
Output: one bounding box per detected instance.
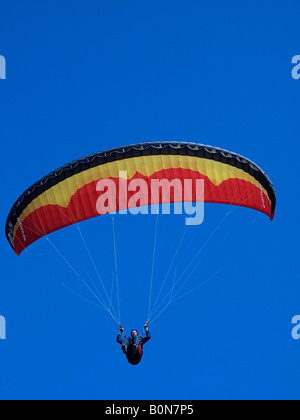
[6,142,276,255]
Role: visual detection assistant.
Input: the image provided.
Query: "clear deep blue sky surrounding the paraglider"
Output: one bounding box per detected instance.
[0,0,300,399]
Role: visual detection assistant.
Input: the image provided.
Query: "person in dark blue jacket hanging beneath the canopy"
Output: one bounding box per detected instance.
[117,321,151,365]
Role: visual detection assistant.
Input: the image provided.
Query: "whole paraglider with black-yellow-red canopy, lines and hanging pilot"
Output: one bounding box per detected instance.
[6,142,276,365]
